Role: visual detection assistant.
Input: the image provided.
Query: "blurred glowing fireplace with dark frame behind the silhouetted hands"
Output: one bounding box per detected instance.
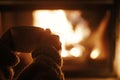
[0,0,117,78]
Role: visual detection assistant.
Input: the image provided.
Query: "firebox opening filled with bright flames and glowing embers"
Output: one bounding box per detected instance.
[33,9,115,76]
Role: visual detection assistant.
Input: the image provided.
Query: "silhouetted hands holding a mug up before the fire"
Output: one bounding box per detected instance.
[0,26,64,80]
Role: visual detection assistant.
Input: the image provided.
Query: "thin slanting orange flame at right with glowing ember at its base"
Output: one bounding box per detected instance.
[90,11,110,59]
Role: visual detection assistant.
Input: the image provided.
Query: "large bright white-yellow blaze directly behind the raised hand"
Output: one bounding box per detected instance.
[33,10,90,57]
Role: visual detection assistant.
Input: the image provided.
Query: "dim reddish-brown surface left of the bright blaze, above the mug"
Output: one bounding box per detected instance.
[0,10,33,35]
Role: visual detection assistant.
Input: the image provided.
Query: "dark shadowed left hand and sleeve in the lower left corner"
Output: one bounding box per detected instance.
[0,43,19,80]
